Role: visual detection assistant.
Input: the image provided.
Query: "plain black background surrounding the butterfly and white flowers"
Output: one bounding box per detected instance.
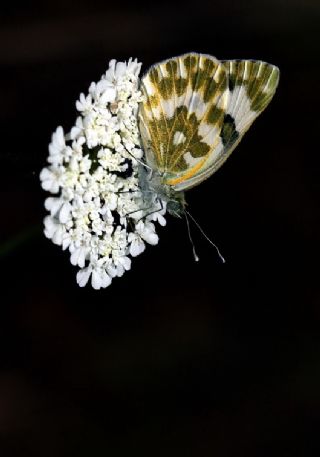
[0,0,320,457]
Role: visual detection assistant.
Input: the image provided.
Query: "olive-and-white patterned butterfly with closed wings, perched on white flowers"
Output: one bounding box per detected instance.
[138,52,280,216]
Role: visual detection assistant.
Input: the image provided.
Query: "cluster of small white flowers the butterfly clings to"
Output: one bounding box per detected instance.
[40,59,166,289]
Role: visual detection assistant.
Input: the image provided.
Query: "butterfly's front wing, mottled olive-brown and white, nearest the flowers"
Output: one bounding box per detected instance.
[139,53,229,186]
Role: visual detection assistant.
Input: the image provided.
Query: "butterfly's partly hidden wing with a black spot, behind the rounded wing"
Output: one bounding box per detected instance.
[174,60,279,191]
